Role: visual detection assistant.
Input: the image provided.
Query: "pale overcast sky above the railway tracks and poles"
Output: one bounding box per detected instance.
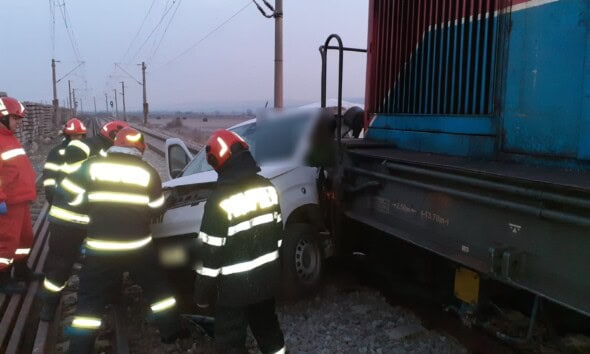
[0,0,368,111]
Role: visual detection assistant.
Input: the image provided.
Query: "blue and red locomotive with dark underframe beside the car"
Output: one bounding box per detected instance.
[335,0,590,316]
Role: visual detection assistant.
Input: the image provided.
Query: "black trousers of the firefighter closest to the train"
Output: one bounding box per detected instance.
[215,298,285,354]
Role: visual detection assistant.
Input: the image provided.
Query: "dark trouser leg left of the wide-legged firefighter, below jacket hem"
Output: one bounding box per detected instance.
[45,222,86,296]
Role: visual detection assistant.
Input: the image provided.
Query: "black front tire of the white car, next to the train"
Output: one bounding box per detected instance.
[281,223,324,300]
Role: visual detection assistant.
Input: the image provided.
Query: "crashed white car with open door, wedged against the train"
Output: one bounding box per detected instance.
[152,108,360,298]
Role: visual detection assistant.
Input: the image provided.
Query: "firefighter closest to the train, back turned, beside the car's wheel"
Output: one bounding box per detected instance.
[195,130,285,353]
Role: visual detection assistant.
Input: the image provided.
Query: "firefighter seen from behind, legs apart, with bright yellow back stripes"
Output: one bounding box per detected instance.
[61,127,179,354]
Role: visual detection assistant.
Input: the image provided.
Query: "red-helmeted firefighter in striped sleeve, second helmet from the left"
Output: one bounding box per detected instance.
[43,118,86,204]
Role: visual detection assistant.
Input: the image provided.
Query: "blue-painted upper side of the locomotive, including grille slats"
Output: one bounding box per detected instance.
[367,0,590,169]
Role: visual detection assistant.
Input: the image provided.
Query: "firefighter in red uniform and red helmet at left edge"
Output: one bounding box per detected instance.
[0,97,37,293]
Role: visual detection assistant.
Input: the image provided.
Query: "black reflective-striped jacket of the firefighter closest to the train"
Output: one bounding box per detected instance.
[195,153,283,306]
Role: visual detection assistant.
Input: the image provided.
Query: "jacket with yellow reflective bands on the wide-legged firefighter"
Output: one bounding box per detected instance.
[60,153,164,252]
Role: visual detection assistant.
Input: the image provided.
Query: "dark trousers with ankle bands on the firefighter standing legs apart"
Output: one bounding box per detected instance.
[69,242,179,354]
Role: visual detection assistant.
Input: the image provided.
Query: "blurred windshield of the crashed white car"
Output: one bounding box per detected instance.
[181,113,310,176]
